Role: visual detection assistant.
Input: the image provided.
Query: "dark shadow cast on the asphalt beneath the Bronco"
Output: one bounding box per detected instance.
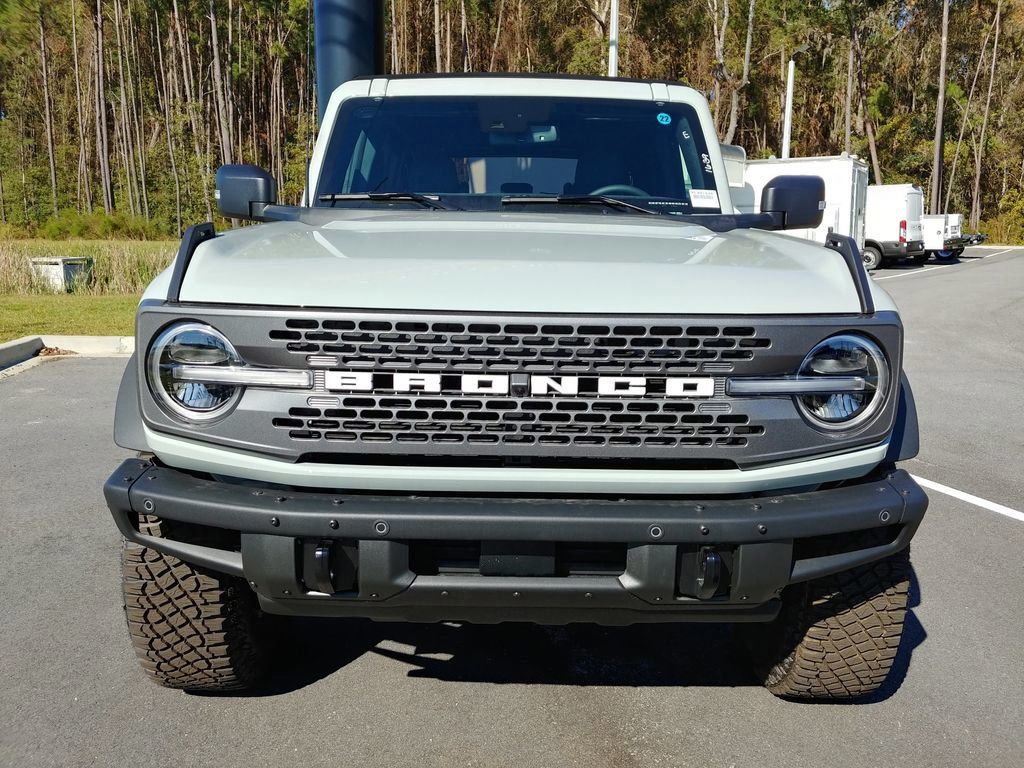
[243,570,927,703]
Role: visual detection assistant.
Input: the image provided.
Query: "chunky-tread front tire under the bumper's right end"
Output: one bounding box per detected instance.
[740,548,910,699]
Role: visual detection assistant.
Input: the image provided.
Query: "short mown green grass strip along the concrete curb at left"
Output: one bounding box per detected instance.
[0,294,138,343]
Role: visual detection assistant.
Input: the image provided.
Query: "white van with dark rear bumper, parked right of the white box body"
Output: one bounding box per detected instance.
[863,184,928,269]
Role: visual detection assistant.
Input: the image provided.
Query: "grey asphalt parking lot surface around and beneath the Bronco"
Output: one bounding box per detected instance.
[0,244,1024,768]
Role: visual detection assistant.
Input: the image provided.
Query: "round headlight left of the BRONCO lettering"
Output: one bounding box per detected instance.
[146,323,243,422]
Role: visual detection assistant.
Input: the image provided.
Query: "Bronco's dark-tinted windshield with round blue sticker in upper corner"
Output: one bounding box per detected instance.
[316,96,720,214]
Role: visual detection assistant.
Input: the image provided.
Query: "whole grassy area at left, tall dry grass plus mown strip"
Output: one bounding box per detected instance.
[0,240,177,342]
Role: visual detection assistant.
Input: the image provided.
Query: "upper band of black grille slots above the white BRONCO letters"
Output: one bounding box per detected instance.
[268,318,771,376]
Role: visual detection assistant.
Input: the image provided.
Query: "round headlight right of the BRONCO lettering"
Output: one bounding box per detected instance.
[797,334,889,429]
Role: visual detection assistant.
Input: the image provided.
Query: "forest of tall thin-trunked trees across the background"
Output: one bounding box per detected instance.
[0,0,1024,243]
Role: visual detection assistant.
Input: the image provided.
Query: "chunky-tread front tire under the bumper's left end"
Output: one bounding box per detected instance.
[121,515,268,691]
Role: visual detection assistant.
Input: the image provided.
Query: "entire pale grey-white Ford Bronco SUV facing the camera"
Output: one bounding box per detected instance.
[104,76,928,698]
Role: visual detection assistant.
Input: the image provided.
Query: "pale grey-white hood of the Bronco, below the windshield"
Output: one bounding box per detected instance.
[180,211,872,314]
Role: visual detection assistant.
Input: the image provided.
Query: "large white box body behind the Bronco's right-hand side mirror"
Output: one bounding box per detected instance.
[726,154,867,250]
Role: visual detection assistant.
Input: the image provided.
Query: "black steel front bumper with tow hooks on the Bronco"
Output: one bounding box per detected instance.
[103,459,928,624]
